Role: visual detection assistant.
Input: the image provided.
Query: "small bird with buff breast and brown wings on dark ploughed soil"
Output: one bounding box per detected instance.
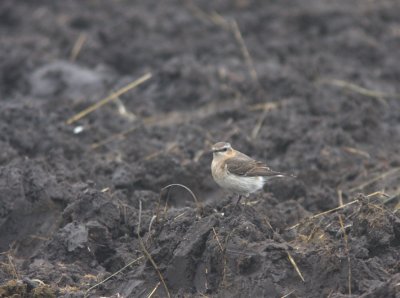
[211,142,285,204]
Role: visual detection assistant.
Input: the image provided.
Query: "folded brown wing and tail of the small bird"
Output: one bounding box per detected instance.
[226,156,283,177]
